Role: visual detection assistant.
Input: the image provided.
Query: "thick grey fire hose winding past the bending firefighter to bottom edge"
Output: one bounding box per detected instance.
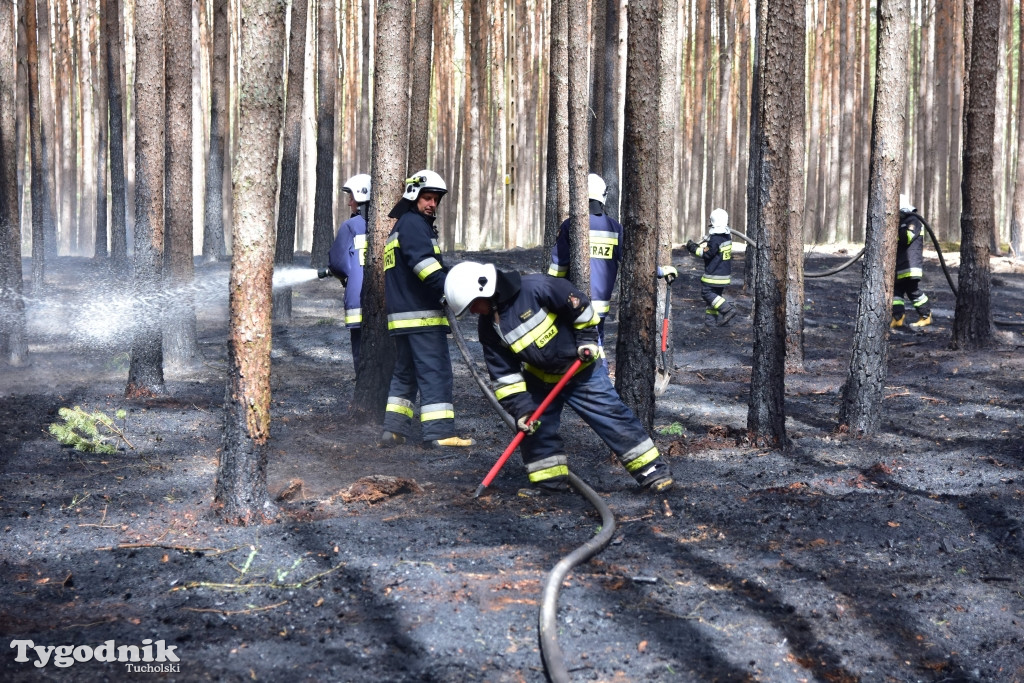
[444,305,615,683]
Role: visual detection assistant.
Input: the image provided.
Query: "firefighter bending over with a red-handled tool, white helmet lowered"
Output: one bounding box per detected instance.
[444,262,673,493]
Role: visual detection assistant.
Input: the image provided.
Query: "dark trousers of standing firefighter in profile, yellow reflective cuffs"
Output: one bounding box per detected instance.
[384,330,455,441]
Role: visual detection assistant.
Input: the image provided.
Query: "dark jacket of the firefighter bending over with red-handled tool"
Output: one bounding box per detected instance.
[477,272,600,416]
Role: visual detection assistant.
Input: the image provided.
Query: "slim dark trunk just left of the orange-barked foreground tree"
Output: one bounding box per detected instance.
[203,0,228,263]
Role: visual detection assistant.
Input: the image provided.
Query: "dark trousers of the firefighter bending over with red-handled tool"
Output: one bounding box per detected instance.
[519,364,658,482]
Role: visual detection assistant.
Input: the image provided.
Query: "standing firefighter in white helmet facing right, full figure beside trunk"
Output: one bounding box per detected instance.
[380,170,475,447]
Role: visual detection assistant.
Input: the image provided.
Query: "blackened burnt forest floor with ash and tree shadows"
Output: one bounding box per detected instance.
[0,250,1024,682]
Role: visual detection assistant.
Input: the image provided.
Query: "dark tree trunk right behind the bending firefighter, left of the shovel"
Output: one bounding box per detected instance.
[615,0,664,430]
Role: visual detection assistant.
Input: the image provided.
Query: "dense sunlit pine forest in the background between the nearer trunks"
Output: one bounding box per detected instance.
[2,0,1024,265]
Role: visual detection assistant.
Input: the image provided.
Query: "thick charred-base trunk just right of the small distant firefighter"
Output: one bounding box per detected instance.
[746,0,805,447]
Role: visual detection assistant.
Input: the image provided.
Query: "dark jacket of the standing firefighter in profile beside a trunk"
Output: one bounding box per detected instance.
[384,209,449,335]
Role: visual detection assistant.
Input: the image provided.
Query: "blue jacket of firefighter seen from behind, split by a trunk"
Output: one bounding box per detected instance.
[548,214,623,317]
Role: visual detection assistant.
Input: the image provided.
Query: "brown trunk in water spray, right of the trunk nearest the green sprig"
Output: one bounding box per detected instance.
[164,0,199,368]
